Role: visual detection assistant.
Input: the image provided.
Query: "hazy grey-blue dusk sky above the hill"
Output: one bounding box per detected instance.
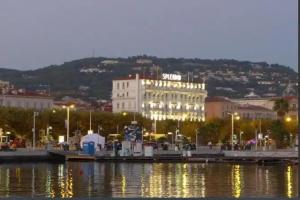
[0,0,298,70]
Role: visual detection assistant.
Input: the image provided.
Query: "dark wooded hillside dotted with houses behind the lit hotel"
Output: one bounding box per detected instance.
[0,56,298,99]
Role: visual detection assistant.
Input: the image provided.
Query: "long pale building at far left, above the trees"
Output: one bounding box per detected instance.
[0,94,53,110]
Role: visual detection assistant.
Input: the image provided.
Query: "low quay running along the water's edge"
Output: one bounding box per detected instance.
[0,149,299,164]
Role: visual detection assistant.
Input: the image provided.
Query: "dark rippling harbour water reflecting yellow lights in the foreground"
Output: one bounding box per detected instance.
[0,162,298,197]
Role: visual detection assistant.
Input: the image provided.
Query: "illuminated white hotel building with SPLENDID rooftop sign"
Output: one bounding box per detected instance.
[112,74,207,121]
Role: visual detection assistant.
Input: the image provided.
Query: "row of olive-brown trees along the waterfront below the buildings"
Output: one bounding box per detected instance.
[0,107,298,147]
